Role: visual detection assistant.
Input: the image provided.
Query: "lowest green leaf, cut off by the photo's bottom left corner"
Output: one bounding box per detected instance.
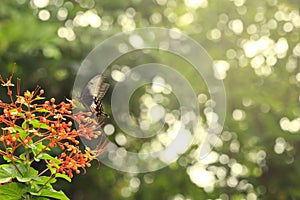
[0,183,26,200]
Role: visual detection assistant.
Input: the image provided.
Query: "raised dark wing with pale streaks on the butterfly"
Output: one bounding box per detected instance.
[80,74,109,108]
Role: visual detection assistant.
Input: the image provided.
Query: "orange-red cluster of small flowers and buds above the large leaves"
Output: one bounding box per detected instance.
[0,73,105,178]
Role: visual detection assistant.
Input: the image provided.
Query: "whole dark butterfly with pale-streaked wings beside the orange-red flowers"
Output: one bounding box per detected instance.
[79,74,109,119]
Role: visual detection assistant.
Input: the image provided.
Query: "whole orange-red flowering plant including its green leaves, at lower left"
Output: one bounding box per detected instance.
[0,75,102,200]
